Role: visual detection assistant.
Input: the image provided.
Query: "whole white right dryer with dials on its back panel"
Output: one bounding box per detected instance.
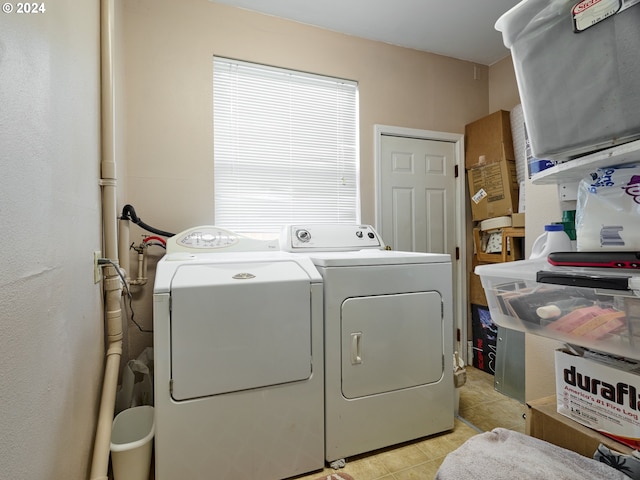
[281,225,455,467]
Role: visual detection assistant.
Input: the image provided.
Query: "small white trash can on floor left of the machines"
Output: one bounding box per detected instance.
[111,405,156,480]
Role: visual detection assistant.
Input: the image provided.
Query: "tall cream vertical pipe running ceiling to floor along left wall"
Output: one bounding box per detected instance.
[89,0,122,480]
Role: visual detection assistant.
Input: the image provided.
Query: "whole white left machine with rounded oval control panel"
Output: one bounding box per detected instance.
[153,226,324,480]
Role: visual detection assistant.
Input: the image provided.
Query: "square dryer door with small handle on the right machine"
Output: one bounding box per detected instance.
[342,292,444,398]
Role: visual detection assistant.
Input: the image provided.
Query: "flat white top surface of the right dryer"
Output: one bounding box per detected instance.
[309,250,451,267]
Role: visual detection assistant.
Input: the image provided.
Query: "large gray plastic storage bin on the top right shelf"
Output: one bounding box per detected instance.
[495,0,640,161]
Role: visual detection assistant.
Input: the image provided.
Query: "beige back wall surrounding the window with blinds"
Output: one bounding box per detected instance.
[120,0,498,355]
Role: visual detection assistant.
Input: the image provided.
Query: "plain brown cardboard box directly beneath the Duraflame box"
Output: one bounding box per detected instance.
[525,395,633,458]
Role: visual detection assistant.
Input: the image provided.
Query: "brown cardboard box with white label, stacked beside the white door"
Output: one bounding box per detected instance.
[467,160,519,221]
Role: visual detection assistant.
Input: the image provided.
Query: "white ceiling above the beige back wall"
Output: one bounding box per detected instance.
[211,0,520,65]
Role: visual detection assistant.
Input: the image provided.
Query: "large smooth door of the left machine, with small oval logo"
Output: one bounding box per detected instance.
[170,261,311,400]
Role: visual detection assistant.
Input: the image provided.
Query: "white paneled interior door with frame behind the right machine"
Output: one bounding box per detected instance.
[375,125,467,357]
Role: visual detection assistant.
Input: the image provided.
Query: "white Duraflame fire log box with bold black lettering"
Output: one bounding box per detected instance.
[555,349,640,449]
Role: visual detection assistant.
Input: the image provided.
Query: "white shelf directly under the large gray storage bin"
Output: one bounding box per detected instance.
[531,140,640,185]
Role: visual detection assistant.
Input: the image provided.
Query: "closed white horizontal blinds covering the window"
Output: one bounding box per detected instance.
[213,57,359,234]
